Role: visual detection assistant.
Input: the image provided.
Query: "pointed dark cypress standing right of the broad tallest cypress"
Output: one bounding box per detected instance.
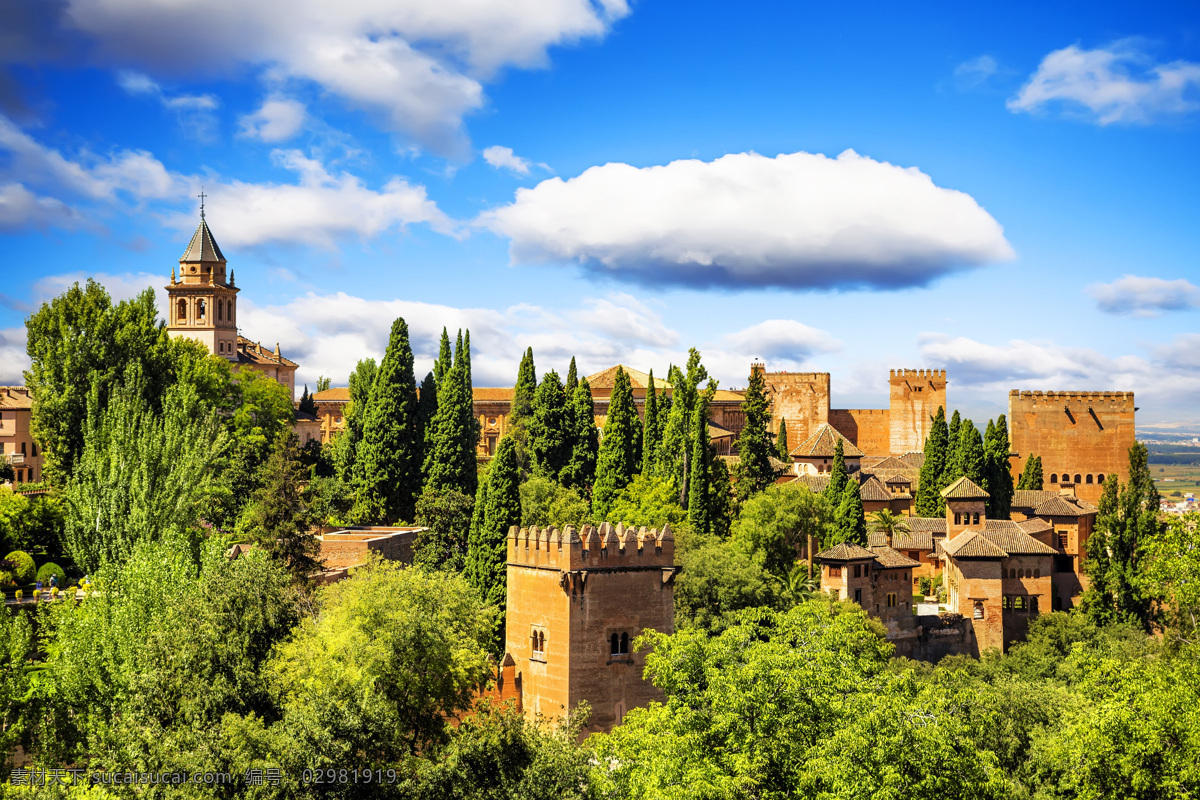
[425,331,479,495]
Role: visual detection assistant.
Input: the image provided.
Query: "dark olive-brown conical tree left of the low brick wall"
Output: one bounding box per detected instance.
[237,434,320,582]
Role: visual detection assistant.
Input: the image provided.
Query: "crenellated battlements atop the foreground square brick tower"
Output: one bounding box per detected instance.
[508,522,674,572]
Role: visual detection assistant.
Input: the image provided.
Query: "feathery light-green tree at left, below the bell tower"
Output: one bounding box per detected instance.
[64,362,228,572]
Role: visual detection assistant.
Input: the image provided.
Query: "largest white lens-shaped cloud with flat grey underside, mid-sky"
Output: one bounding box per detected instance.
[476,150,1013,289]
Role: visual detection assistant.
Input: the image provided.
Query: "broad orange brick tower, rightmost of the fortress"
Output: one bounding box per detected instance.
[1008,390,1136,504]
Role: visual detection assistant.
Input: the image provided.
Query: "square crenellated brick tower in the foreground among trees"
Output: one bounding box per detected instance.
[505,523,676,732]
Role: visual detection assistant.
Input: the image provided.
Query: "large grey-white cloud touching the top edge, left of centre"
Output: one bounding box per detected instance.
[66,0,629,151]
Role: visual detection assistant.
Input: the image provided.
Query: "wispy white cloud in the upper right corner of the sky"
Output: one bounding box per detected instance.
[1008,40,1200,125]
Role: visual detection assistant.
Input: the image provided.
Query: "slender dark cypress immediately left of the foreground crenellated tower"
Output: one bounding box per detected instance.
[464,437,521,648]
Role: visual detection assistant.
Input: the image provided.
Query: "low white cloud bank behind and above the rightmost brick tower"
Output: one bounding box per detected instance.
[920,333,1200,420]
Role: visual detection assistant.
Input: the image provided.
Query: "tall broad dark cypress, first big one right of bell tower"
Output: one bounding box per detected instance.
[355,318,421,524]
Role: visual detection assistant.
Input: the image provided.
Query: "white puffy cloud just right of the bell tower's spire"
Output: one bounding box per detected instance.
[168,150,456,247]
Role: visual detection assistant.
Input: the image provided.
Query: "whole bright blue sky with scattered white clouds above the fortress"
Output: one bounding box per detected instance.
[0,0,1200,422]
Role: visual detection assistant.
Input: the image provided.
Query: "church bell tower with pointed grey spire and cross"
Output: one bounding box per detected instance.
[167,193,238,361]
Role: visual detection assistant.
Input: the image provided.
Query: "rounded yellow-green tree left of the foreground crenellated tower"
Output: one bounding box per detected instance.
[266,560,494,777]
